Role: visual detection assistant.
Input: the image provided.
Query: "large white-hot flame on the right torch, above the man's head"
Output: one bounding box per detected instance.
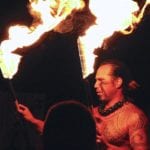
[78,0,150,77]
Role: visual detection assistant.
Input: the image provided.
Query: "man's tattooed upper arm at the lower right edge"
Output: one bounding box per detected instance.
[129,113,150,150]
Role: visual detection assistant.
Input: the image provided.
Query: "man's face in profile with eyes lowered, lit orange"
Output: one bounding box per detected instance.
[94,64,117,102]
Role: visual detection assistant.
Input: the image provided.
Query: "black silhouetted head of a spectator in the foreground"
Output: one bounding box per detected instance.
[43,100,96,150]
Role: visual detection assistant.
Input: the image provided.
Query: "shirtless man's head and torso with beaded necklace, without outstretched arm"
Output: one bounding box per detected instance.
[93,60,150,150]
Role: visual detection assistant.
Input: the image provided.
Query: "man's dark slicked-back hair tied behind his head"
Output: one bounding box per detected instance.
[99,59,139,94]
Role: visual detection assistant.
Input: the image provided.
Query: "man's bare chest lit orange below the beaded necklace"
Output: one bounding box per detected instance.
[96,109,128,145]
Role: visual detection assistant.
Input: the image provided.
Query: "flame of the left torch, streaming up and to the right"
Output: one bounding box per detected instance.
[0,0,85,79]
